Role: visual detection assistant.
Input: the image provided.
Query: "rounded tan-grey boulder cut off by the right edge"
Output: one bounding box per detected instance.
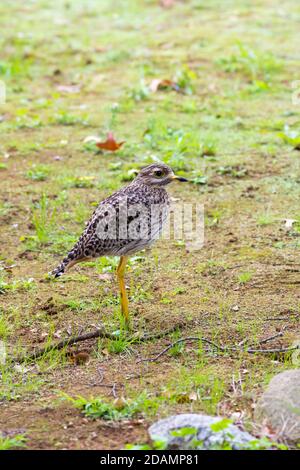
[255,369,300,444]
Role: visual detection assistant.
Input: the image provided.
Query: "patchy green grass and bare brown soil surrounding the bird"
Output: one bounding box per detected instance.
[0,0,300,448]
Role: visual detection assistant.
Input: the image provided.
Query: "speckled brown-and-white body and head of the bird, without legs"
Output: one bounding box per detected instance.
[52,164,176,277]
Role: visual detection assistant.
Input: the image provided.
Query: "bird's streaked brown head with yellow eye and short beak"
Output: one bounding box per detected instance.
[135,163,188,186]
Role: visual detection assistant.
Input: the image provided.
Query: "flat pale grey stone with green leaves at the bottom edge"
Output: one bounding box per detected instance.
[148,414,256,450]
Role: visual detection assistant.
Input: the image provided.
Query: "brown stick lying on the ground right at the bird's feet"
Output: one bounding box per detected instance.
[12,323,184,363]
